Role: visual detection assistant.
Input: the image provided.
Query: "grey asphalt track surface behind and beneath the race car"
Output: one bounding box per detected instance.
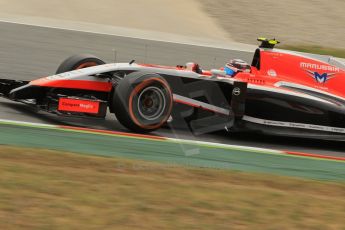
[0,22,345,157]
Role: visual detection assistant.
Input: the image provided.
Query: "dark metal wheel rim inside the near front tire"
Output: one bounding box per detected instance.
[138,86,166,121]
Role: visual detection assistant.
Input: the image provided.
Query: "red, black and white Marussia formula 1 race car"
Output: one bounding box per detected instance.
[0,38,345,140]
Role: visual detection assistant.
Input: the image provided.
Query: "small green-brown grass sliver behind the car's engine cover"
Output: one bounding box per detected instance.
[278,45,345,58]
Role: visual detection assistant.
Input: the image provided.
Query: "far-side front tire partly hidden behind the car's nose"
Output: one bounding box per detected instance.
[56,54,105,74]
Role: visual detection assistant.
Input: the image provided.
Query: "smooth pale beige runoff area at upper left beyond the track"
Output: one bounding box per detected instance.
[0,0,230,41]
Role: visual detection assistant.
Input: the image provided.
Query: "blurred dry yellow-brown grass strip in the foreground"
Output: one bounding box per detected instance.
[0,146,345,229]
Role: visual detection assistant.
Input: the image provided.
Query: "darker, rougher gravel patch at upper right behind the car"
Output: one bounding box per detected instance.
[198,0,345,49]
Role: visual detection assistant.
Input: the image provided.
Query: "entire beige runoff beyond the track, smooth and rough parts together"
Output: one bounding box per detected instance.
[0,0,345,49]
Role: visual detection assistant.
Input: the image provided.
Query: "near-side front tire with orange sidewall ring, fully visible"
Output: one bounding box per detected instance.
[112,72,173,133]
